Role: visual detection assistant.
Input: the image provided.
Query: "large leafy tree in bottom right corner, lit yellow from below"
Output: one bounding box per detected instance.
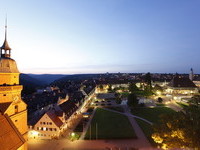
[152,105,200,149]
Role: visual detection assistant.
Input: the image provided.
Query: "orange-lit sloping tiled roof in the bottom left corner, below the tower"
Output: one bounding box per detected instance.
[0,113,25,150]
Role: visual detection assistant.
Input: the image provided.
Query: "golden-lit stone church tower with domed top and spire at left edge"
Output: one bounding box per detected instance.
[0,20,28,150]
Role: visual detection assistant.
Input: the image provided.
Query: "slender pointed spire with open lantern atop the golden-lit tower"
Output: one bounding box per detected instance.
[1,15,11,58]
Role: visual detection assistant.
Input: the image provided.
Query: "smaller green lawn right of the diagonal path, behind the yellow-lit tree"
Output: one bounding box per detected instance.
[132,107,175,123]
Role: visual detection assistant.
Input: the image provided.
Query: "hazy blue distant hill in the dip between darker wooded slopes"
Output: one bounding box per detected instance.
[28,74,66,85]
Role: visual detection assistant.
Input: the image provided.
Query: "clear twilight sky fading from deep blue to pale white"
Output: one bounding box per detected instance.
[0,0,200,74]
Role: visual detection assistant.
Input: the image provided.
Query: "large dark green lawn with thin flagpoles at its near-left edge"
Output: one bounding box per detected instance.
[85,108,137,139]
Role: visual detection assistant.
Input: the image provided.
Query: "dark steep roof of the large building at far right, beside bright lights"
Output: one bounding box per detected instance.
[169,75,196,88]
